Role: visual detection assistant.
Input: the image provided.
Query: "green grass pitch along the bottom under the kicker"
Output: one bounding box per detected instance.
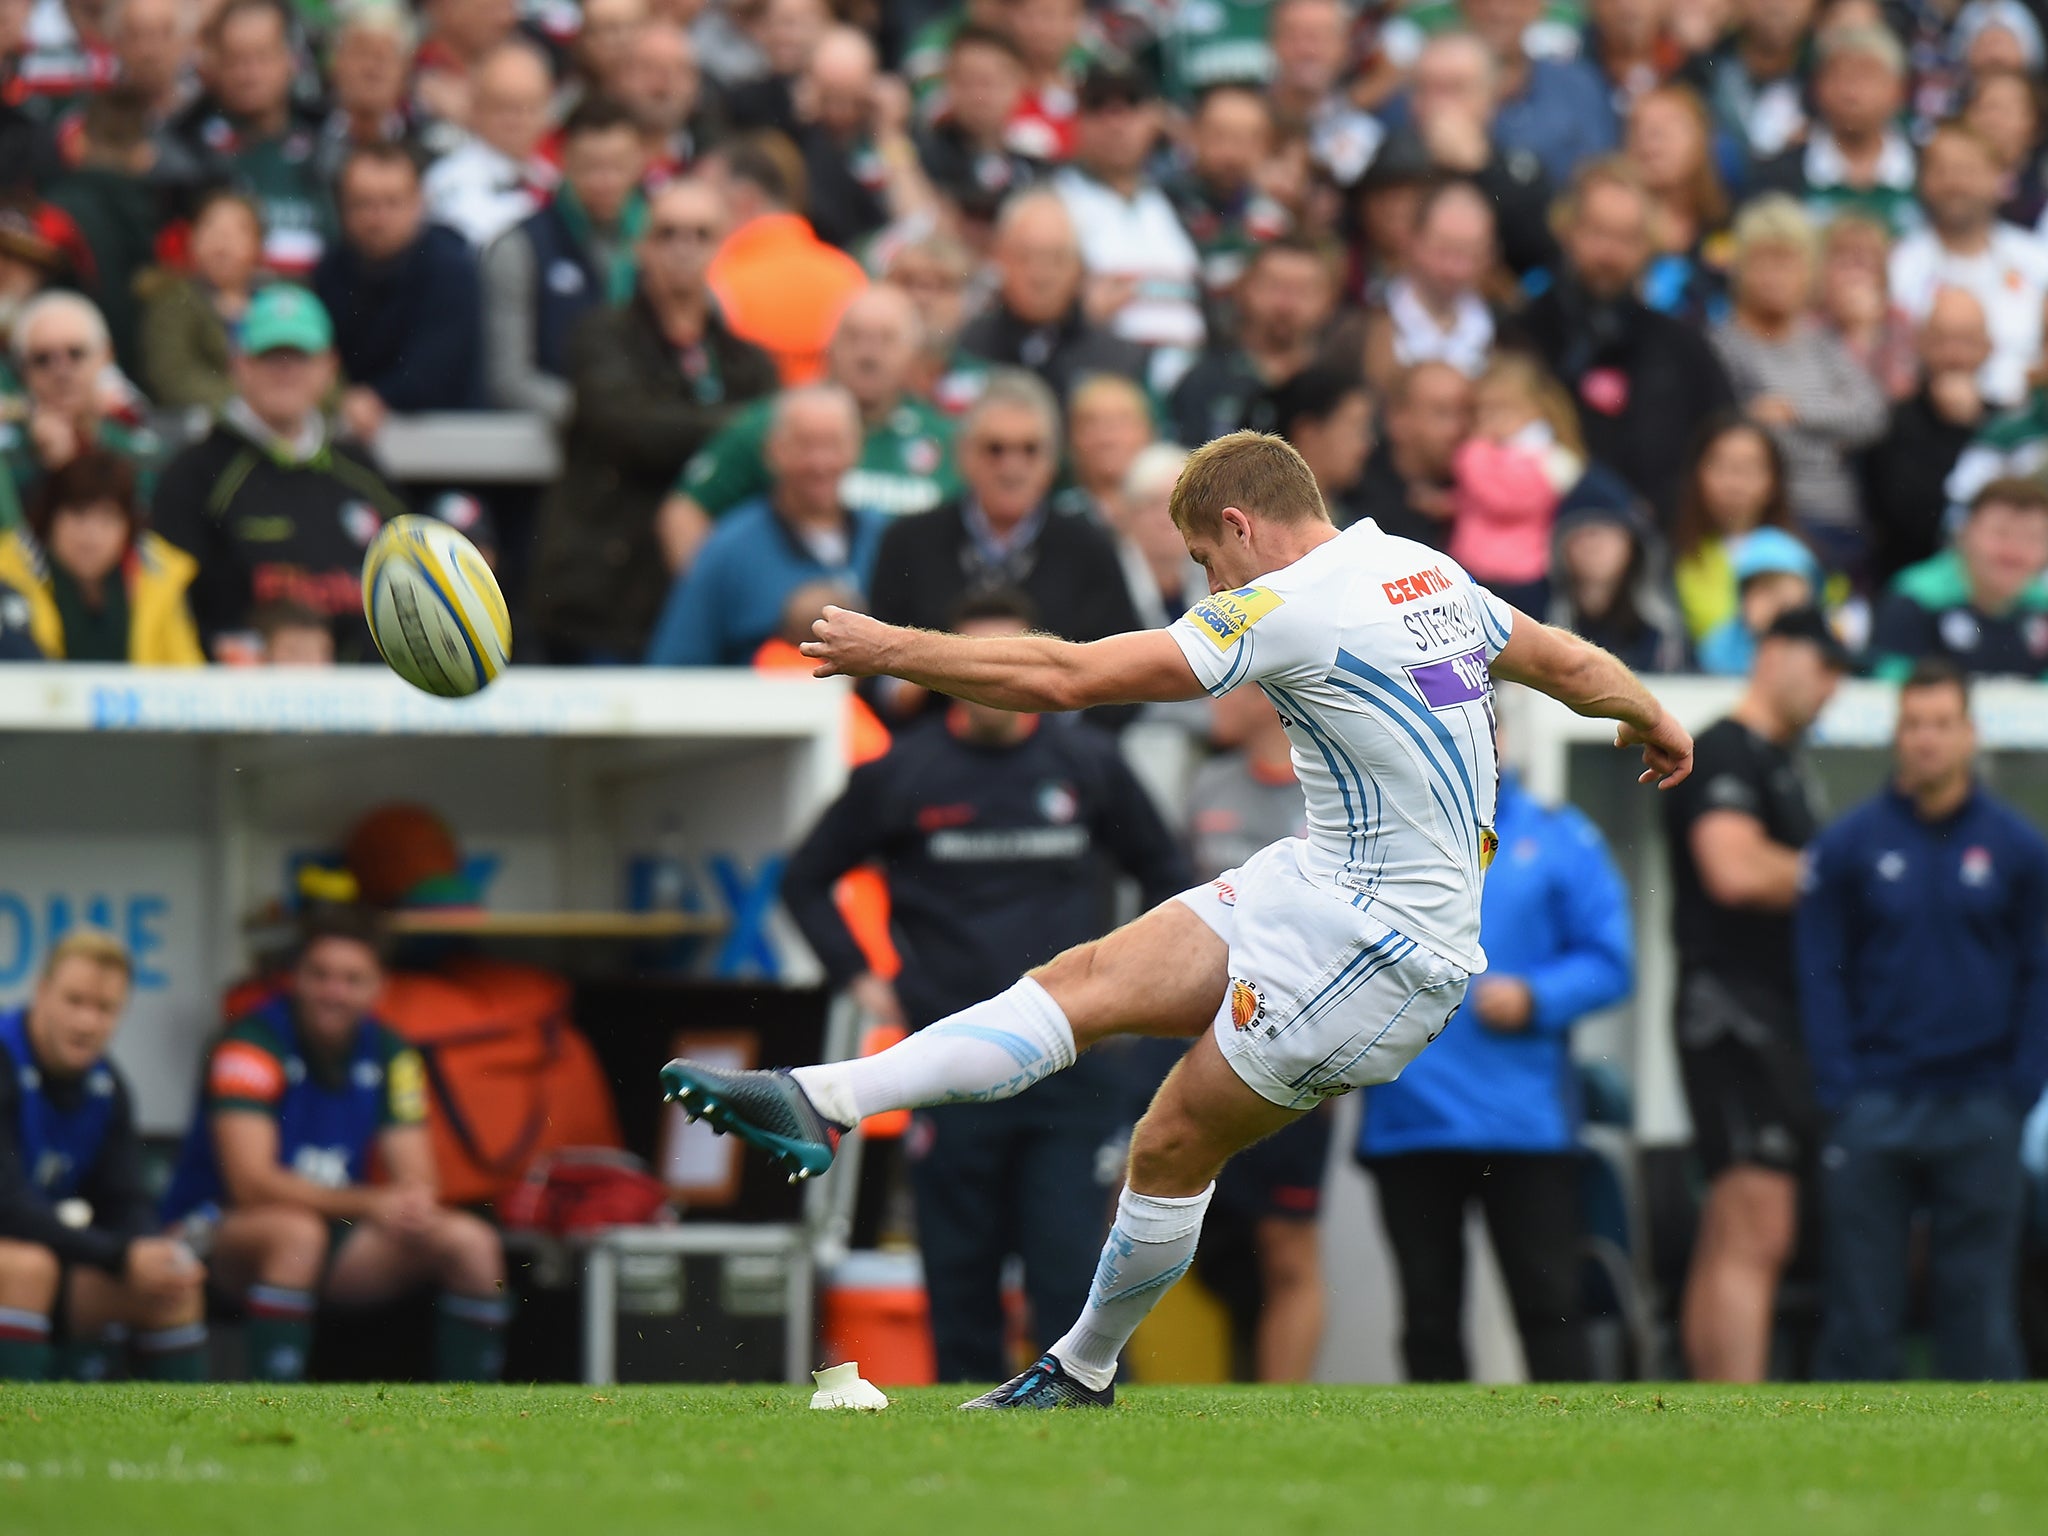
[0,1384,2048,1536]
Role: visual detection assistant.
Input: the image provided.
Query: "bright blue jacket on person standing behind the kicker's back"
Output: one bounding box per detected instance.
[1358,774,1634,1157]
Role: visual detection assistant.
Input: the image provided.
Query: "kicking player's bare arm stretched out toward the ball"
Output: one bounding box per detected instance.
[803,606,1204,713]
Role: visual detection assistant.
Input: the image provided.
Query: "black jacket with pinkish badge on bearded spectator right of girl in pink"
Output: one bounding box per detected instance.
[1503,276,1735,528]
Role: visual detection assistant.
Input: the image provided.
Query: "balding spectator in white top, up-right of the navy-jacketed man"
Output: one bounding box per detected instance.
[424,41,557,250]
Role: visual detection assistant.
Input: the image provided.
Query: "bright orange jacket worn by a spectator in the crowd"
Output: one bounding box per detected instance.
[705,213,868,385]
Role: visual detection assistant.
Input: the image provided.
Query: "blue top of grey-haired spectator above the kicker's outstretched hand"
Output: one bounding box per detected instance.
[647,498,887,668]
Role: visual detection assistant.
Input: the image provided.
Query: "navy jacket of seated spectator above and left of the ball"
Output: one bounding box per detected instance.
[313,223,483,412]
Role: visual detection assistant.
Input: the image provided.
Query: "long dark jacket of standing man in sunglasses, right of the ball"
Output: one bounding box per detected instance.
[530,295,776,662]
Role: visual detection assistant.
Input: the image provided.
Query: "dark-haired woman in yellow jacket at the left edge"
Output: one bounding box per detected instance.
[0,449,207,666]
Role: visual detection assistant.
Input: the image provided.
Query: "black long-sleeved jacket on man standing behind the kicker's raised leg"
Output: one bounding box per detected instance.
[782,717,1194,1028]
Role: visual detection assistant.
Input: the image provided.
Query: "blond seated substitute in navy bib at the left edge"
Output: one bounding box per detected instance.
[0,928,207,1380]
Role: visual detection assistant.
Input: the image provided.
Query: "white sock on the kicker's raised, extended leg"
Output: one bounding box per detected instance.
[793,977,1073,1126]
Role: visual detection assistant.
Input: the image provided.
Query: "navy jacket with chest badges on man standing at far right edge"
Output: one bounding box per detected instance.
[1798,788,2048,1108]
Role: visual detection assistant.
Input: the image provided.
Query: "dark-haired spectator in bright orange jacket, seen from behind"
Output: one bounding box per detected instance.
[709,137,868,385]
